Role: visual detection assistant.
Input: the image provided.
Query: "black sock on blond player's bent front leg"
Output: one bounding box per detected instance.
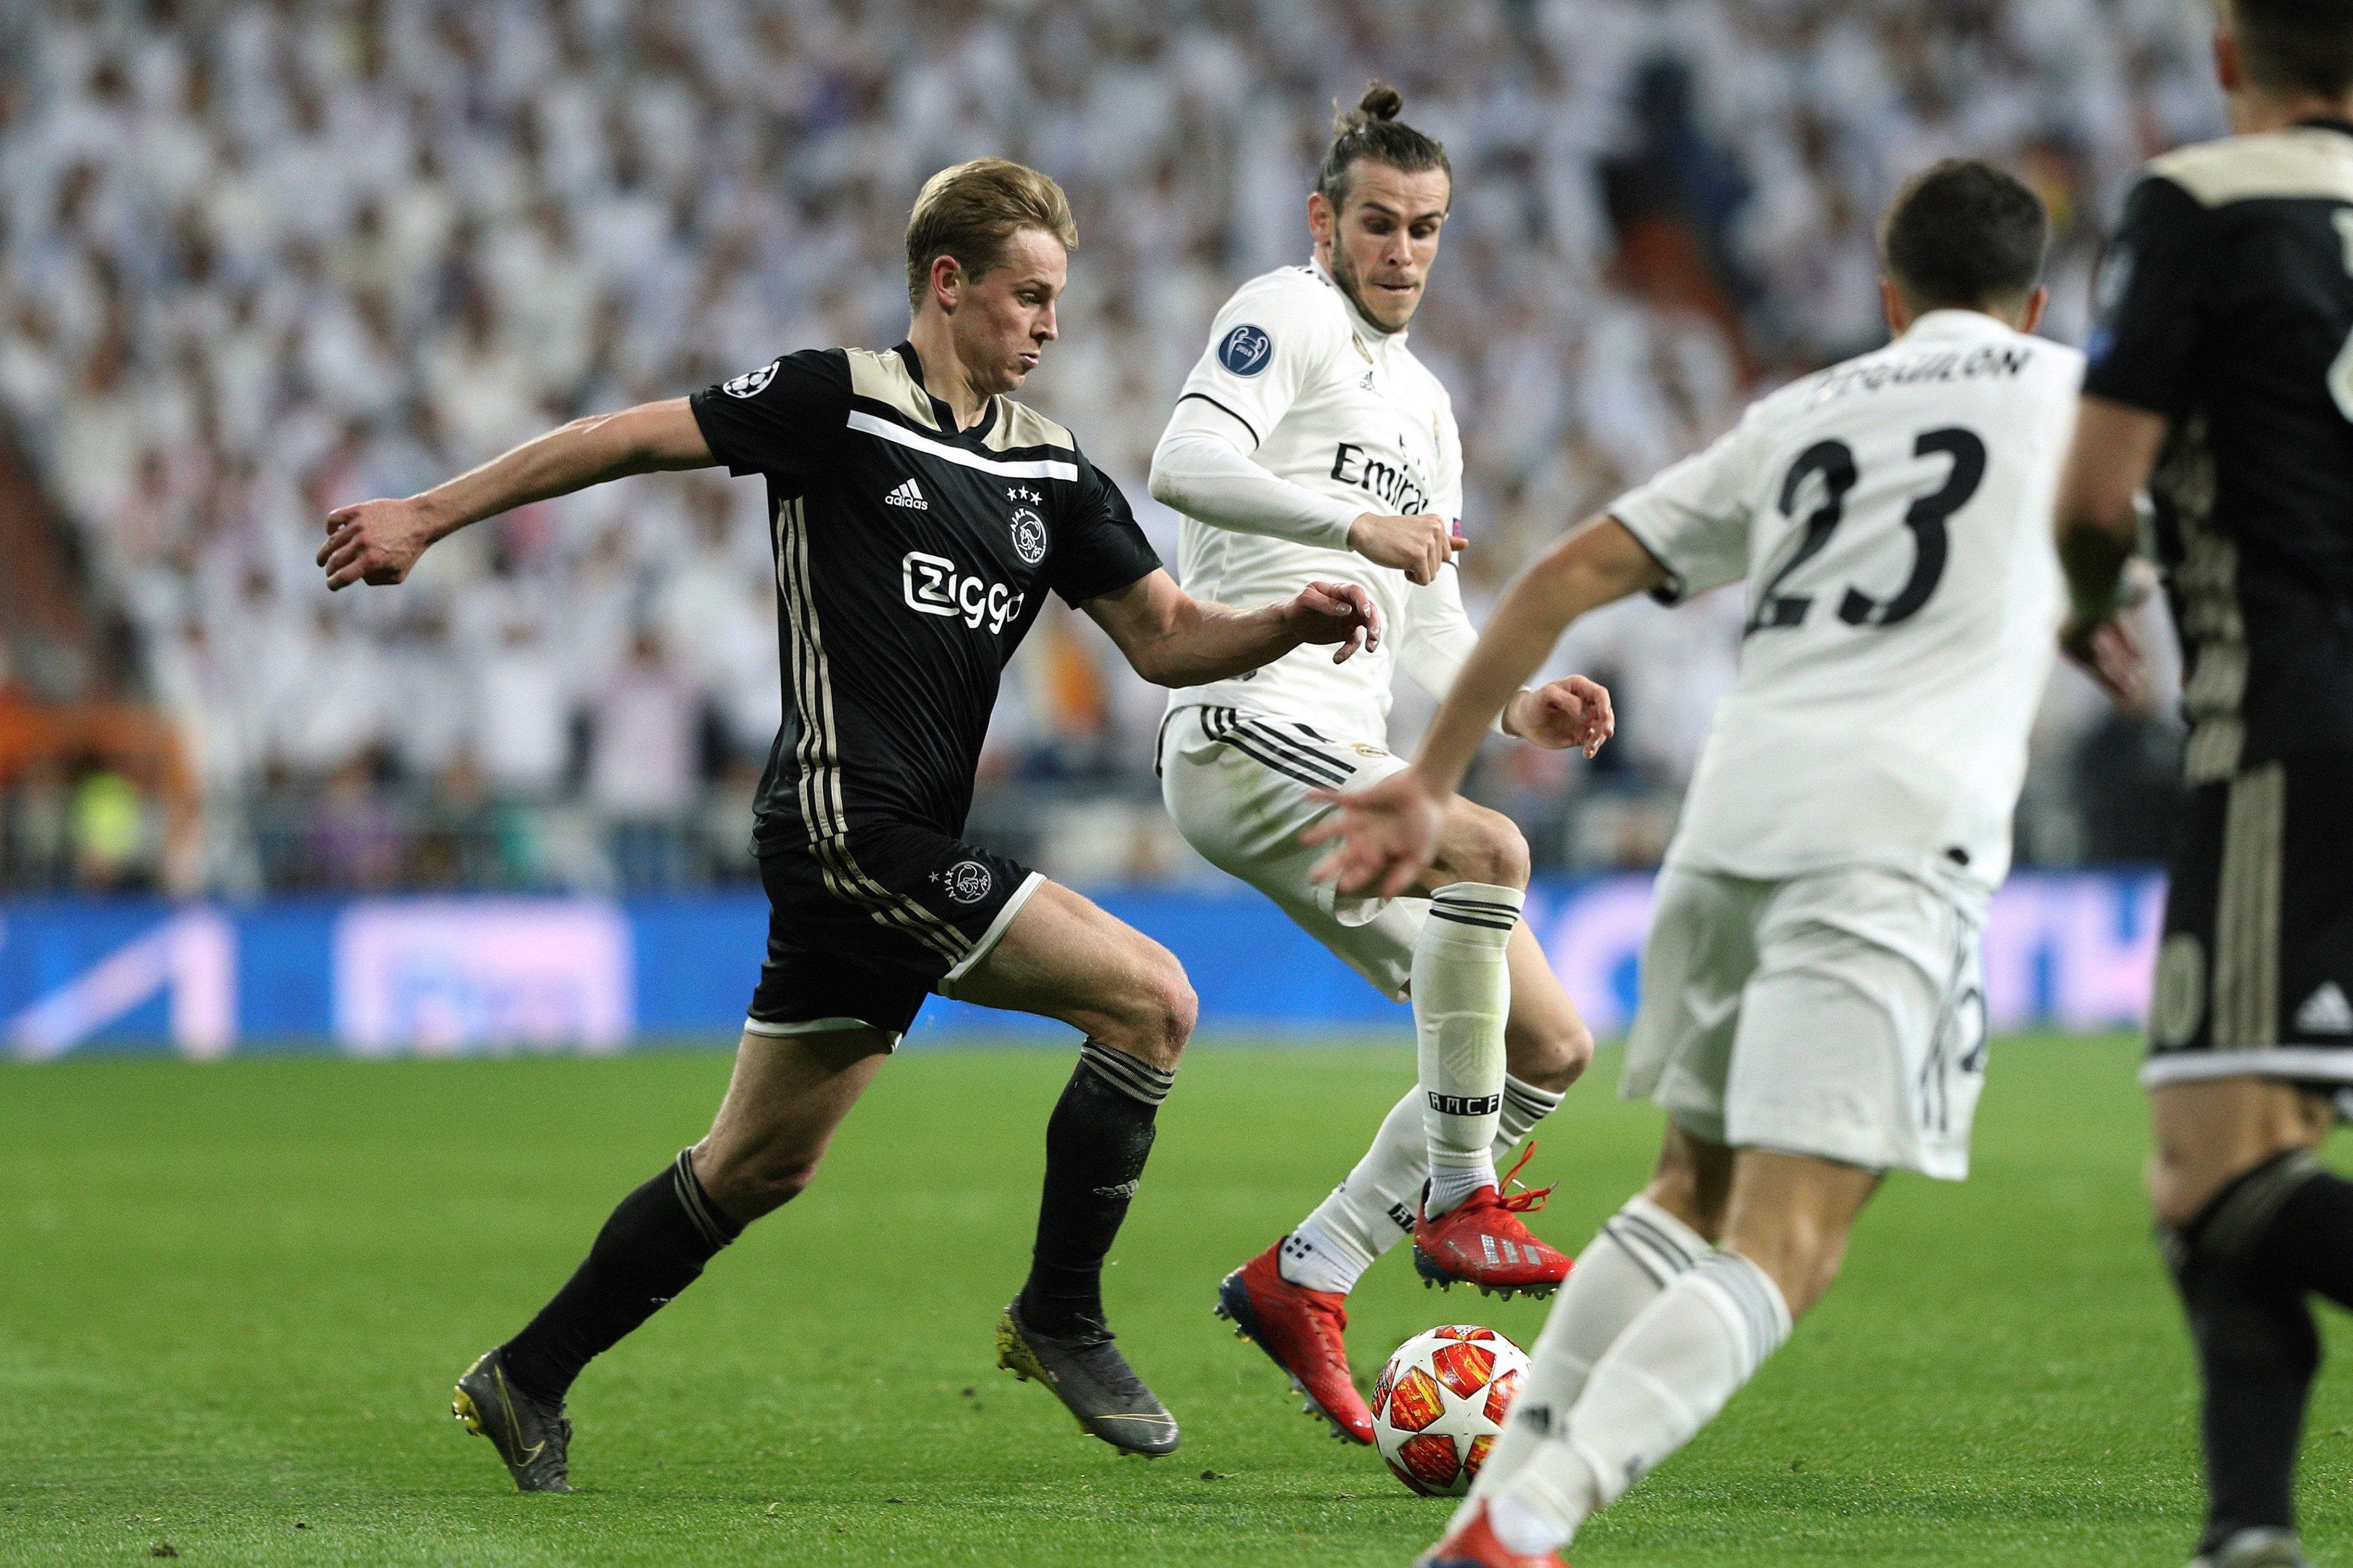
[1021,1040,1176,1335]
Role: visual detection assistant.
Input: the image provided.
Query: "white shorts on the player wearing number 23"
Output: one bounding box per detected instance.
[1619,866,1986,1182]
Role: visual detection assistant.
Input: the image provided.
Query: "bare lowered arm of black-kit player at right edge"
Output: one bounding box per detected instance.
[2059,396,2167,702]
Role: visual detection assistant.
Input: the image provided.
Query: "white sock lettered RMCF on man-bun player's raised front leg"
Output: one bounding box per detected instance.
[1414,883,1520,1217]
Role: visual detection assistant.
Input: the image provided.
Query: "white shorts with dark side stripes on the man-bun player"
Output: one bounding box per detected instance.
[1160,706,1431,1000]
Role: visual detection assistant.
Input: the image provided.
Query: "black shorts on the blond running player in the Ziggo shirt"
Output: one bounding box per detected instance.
[744,822,1045,1045]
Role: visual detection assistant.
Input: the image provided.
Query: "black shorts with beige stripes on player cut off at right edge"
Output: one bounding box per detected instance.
[2141,753,2353,1090]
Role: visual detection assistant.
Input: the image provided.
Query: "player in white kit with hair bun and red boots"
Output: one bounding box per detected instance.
[1151,82,1609,1443]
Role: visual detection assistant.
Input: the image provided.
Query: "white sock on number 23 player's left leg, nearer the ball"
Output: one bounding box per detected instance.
[1464,1194,1715,1507]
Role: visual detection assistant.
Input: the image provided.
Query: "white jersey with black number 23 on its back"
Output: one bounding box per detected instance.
[1609,311,2082,892]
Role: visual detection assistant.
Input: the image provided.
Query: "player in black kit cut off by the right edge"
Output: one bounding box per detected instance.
[2059,0,2353,1568]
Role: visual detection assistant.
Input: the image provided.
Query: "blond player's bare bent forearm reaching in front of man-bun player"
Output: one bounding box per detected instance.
[1082,572,1381,685]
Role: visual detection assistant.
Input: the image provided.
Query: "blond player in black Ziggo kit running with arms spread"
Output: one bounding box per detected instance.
[320,158,1379,1490]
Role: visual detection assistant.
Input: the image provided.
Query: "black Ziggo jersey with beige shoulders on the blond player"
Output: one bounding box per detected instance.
[689,343,1160,852]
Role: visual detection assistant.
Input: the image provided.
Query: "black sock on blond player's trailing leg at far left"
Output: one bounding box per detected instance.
[501,1149,744,1401]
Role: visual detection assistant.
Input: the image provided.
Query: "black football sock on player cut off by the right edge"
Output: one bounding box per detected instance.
[2165,1151,2353,1552]
